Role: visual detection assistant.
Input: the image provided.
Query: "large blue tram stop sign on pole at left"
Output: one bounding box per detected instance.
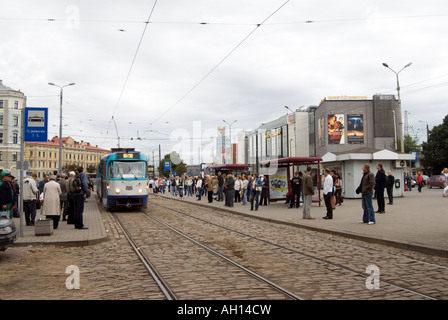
[24,108,48,142]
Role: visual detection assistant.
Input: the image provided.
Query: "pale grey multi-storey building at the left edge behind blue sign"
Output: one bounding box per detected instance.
[0,80,26,174]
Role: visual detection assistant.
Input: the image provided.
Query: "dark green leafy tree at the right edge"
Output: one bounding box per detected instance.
[422,115,448,172]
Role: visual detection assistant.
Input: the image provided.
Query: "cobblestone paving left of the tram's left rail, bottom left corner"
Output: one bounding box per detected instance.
[0,205,164,300]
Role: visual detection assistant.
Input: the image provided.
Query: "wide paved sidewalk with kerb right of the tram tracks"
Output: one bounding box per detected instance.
[155,188,448,257]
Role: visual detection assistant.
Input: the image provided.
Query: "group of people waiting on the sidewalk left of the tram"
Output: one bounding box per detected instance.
[0,167,93,229]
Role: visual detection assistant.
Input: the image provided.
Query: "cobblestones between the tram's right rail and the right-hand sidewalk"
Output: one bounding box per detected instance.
[148,198,448,299]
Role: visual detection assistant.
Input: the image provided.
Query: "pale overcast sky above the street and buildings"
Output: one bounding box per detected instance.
[0,0,448,162]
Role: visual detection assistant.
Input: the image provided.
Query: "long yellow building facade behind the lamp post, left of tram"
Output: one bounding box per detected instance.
[25,137,110,178]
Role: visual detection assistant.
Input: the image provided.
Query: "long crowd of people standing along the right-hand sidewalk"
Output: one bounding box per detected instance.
[150,163,448,225]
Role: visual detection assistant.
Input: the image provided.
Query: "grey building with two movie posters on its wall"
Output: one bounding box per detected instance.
[315,95,402,157]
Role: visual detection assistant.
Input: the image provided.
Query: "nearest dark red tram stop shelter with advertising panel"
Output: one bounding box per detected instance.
[261,157,322,207]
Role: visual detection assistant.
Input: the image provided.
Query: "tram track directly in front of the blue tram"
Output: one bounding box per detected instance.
[113,213,302,300]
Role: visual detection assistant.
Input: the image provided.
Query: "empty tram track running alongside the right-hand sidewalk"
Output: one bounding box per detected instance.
[151,196,447,300]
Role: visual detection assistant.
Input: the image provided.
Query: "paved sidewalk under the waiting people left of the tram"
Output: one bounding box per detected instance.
[14,197,107,246]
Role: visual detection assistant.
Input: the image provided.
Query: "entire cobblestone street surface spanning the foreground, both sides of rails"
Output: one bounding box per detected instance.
[0,198,448,300]
